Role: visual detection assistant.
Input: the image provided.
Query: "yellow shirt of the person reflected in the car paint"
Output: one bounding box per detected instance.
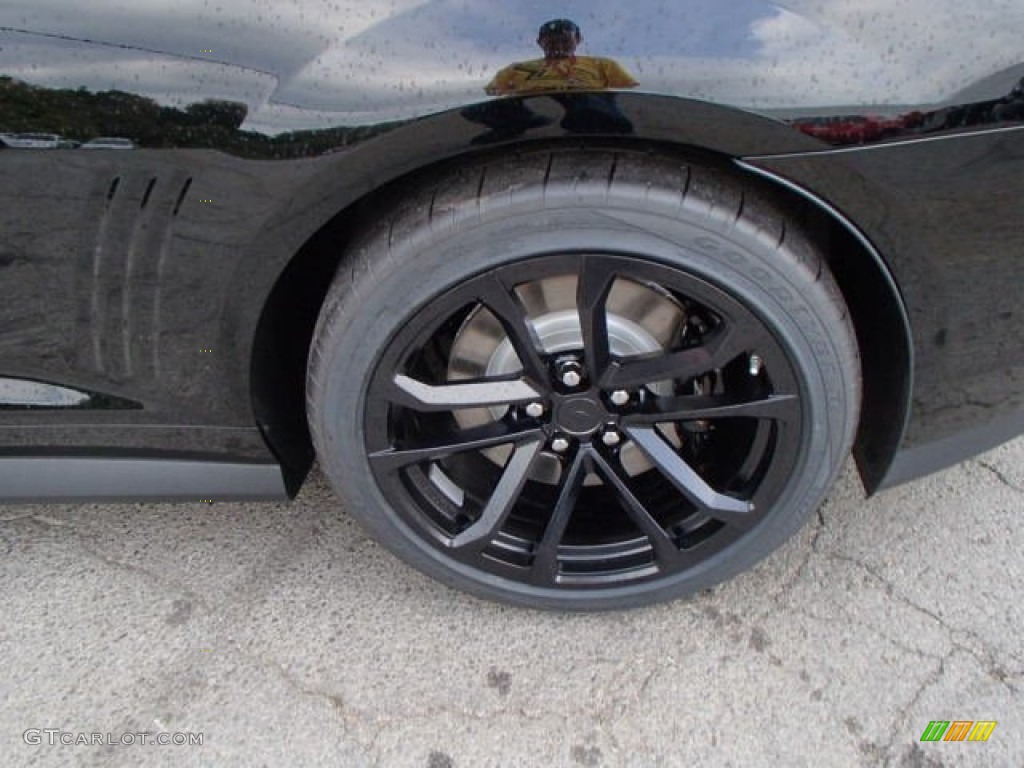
[484,56,638,96]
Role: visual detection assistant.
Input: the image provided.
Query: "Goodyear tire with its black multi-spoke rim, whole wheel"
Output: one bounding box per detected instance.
[307,150,860,610]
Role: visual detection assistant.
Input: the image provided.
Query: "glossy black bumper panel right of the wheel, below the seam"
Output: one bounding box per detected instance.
[752,128,1024,454]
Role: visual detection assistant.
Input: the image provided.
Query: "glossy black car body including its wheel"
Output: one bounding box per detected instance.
[0,0,1024,609]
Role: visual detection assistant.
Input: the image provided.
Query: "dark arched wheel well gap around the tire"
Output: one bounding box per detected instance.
[250,139,912,495]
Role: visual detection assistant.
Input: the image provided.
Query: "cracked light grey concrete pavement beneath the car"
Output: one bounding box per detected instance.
[0,439,1024,768]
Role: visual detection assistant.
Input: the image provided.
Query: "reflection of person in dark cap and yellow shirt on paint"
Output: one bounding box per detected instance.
[484,18,637,96]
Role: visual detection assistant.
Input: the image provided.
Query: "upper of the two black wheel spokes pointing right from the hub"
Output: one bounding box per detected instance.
[600,328,756,389]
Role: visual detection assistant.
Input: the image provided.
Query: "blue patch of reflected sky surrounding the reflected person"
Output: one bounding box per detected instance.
[275,0,777,111]
